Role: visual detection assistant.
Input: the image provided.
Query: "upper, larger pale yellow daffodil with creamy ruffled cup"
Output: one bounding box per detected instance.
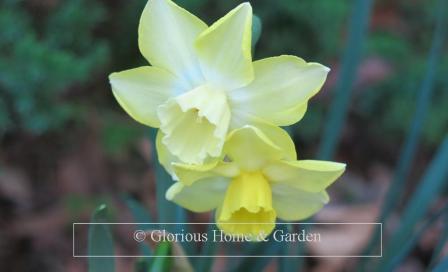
[109,0,329,164]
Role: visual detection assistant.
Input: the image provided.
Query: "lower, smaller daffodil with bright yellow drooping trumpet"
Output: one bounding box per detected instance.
[166,126,345,236]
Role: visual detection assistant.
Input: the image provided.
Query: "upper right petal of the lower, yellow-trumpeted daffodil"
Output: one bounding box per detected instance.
[263,160,345,192]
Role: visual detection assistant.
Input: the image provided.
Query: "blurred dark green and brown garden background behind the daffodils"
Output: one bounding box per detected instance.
[0,0,448,271]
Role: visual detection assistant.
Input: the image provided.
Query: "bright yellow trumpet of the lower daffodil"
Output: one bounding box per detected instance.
[217,172,276,238]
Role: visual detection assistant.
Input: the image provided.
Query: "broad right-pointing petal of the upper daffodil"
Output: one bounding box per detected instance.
[229,55,330,126]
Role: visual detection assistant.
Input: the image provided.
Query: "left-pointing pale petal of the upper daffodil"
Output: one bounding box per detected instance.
[109,66,178,127]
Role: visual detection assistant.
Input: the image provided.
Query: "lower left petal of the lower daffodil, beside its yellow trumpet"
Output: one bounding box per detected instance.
[166,178,229,212]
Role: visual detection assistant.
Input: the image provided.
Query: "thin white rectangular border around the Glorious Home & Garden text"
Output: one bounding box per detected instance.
[72,222,383,258]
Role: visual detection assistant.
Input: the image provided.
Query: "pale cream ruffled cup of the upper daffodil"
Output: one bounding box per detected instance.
[157,85,230,164]
